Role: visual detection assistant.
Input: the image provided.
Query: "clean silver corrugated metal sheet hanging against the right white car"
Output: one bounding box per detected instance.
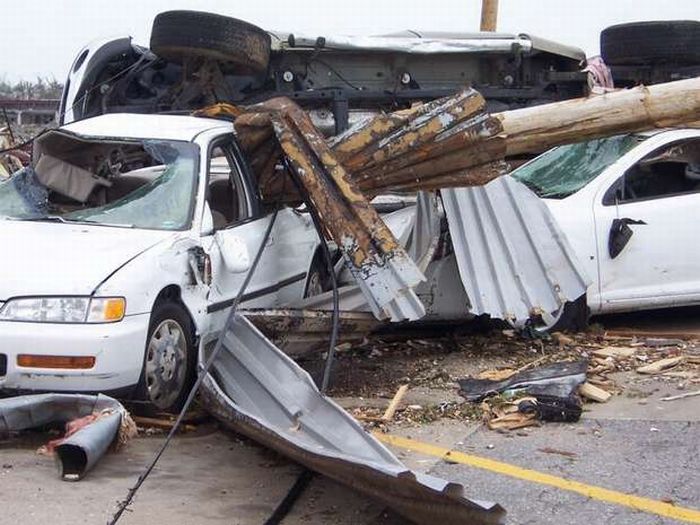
[441,177,590,325]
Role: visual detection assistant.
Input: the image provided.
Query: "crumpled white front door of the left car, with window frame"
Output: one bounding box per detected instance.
[202,136,318,325]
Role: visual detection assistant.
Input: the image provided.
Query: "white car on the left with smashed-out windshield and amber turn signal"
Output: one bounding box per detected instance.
[0,114,319,410]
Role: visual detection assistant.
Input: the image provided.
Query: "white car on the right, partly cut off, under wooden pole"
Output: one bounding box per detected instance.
[512,129,700,320]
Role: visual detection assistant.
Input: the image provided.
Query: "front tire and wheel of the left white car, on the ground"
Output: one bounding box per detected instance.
[136,302,197,413]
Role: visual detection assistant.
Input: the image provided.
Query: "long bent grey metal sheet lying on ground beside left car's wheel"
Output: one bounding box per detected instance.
[200,315,505,525]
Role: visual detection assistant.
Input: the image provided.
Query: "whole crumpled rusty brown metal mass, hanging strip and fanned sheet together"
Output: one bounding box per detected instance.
[230,89,507,321]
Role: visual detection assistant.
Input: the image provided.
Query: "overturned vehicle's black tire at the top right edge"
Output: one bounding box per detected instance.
[600,20,700,65]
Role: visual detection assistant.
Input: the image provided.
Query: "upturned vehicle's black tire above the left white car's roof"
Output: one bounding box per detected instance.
[151,11,270,74]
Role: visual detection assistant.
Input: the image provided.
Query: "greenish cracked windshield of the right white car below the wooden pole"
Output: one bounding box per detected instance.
[511,135,645,199]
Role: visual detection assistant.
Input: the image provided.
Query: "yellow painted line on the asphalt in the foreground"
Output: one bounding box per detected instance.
[374,432,700,523]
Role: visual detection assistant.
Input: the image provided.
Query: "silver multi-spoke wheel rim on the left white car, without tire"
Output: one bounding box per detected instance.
[145,319,187,410]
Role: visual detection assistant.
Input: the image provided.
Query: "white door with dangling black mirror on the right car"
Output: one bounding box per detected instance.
[593,136,700,312]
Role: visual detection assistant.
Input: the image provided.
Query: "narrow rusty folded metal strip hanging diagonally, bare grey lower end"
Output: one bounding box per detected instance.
[235,98,425,321]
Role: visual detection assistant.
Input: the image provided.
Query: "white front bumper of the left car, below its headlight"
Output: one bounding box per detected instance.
[0,314,150,392]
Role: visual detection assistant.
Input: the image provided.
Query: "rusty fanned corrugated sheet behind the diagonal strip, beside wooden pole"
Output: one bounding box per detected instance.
[235,89,508,202]
